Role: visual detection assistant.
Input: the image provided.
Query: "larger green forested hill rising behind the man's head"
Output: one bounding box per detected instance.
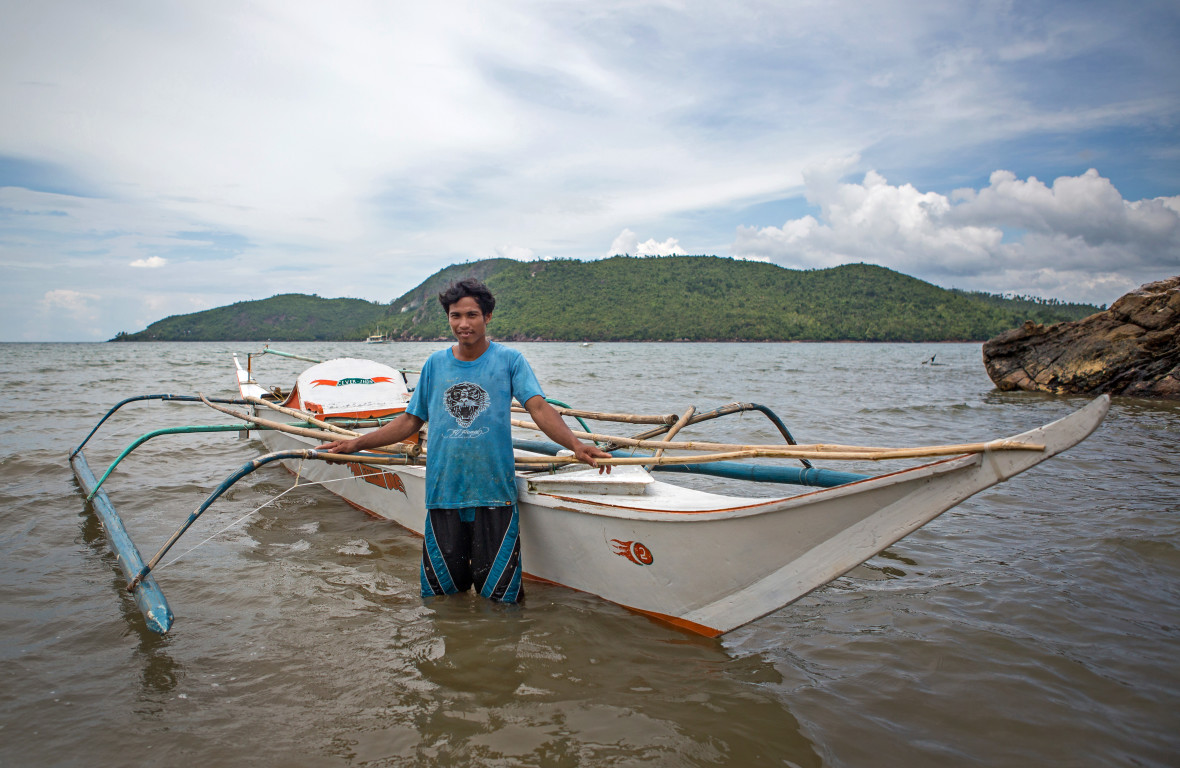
[379,256,1099,341]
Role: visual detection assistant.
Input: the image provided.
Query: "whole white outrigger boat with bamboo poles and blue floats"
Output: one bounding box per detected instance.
[71,349,1110,637]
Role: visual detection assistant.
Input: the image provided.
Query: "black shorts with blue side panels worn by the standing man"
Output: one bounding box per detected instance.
[421,504,523,603]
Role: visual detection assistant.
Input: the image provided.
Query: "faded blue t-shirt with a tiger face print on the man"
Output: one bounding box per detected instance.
[406,342,544,510]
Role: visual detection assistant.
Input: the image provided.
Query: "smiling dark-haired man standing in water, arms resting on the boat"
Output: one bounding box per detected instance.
[319,278,610,603]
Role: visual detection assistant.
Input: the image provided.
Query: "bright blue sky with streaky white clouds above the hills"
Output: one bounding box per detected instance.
[0,0,1180,341]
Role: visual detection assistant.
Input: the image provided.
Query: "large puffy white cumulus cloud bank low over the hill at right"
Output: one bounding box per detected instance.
[733,158,1180,303]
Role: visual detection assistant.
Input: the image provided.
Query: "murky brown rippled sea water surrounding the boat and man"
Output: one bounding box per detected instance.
[0,342,1180,768]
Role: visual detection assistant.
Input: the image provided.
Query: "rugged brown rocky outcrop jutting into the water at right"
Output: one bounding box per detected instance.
[983,275,1180,400]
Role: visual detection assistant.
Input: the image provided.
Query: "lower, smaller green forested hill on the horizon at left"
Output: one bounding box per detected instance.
[112,294,388,341]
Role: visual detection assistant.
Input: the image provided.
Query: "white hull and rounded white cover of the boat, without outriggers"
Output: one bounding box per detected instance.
[219,357,1109,637]
